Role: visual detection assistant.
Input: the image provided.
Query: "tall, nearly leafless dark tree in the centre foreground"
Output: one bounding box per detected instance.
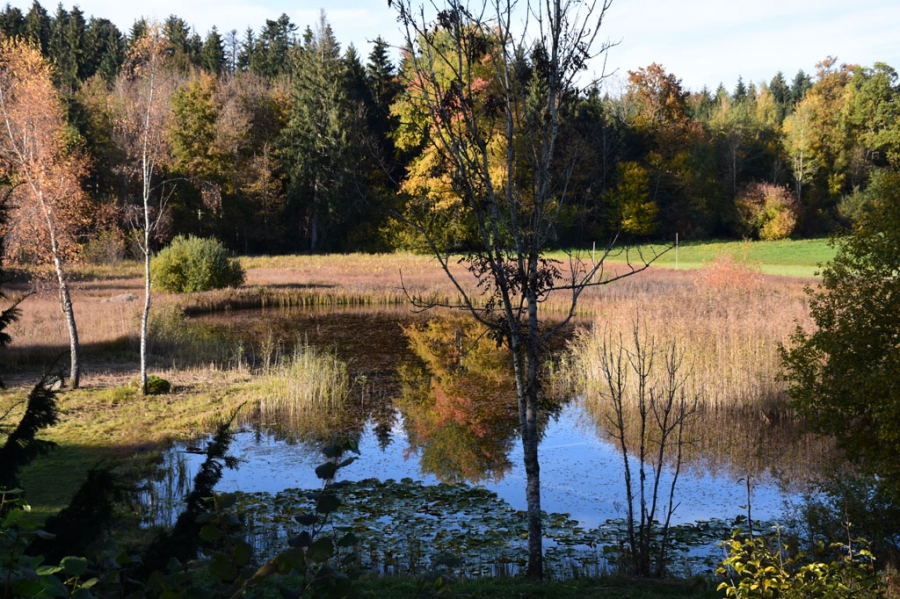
[393,0,664,579]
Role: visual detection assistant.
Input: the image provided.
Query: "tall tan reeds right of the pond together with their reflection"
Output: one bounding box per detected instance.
[559,257,836,484]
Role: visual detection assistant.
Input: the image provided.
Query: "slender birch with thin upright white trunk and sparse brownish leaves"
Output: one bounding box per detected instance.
[115,25,174,393]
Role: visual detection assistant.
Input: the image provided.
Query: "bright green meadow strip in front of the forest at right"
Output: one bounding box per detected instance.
[552,238,835,277]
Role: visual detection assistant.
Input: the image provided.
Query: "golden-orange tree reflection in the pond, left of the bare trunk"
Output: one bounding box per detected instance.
[398,318,518,482]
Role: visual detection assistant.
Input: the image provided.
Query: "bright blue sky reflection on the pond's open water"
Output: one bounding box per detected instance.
[179,404,788,527]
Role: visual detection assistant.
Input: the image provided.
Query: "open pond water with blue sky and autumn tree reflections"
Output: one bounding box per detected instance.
[148,309,824,576]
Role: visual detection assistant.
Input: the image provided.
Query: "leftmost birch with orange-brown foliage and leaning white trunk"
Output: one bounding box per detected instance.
[0,39,89,387]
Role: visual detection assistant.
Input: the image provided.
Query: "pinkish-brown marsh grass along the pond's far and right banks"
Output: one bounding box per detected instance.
[4,254,808,404]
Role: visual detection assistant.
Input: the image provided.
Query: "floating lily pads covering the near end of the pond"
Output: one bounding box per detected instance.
[229,478,739,578]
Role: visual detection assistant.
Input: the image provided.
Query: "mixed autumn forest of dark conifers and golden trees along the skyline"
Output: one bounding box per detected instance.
[0,2,900,263]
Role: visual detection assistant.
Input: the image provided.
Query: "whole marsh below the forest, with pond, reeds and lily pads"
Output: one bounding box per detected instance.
[0,241,872,596]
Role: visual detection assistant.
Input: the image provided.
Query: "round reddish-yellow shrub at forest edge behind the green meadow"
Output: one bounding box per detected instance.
[735,183,799,241]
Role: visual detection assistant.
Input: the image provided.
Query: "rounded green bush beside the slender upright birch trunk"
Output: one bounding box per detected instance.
[150,235,244,293]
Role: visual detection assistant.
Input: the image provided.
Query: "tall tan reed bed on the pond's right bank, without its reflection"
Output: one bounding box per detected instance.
[566,263,810,413]
